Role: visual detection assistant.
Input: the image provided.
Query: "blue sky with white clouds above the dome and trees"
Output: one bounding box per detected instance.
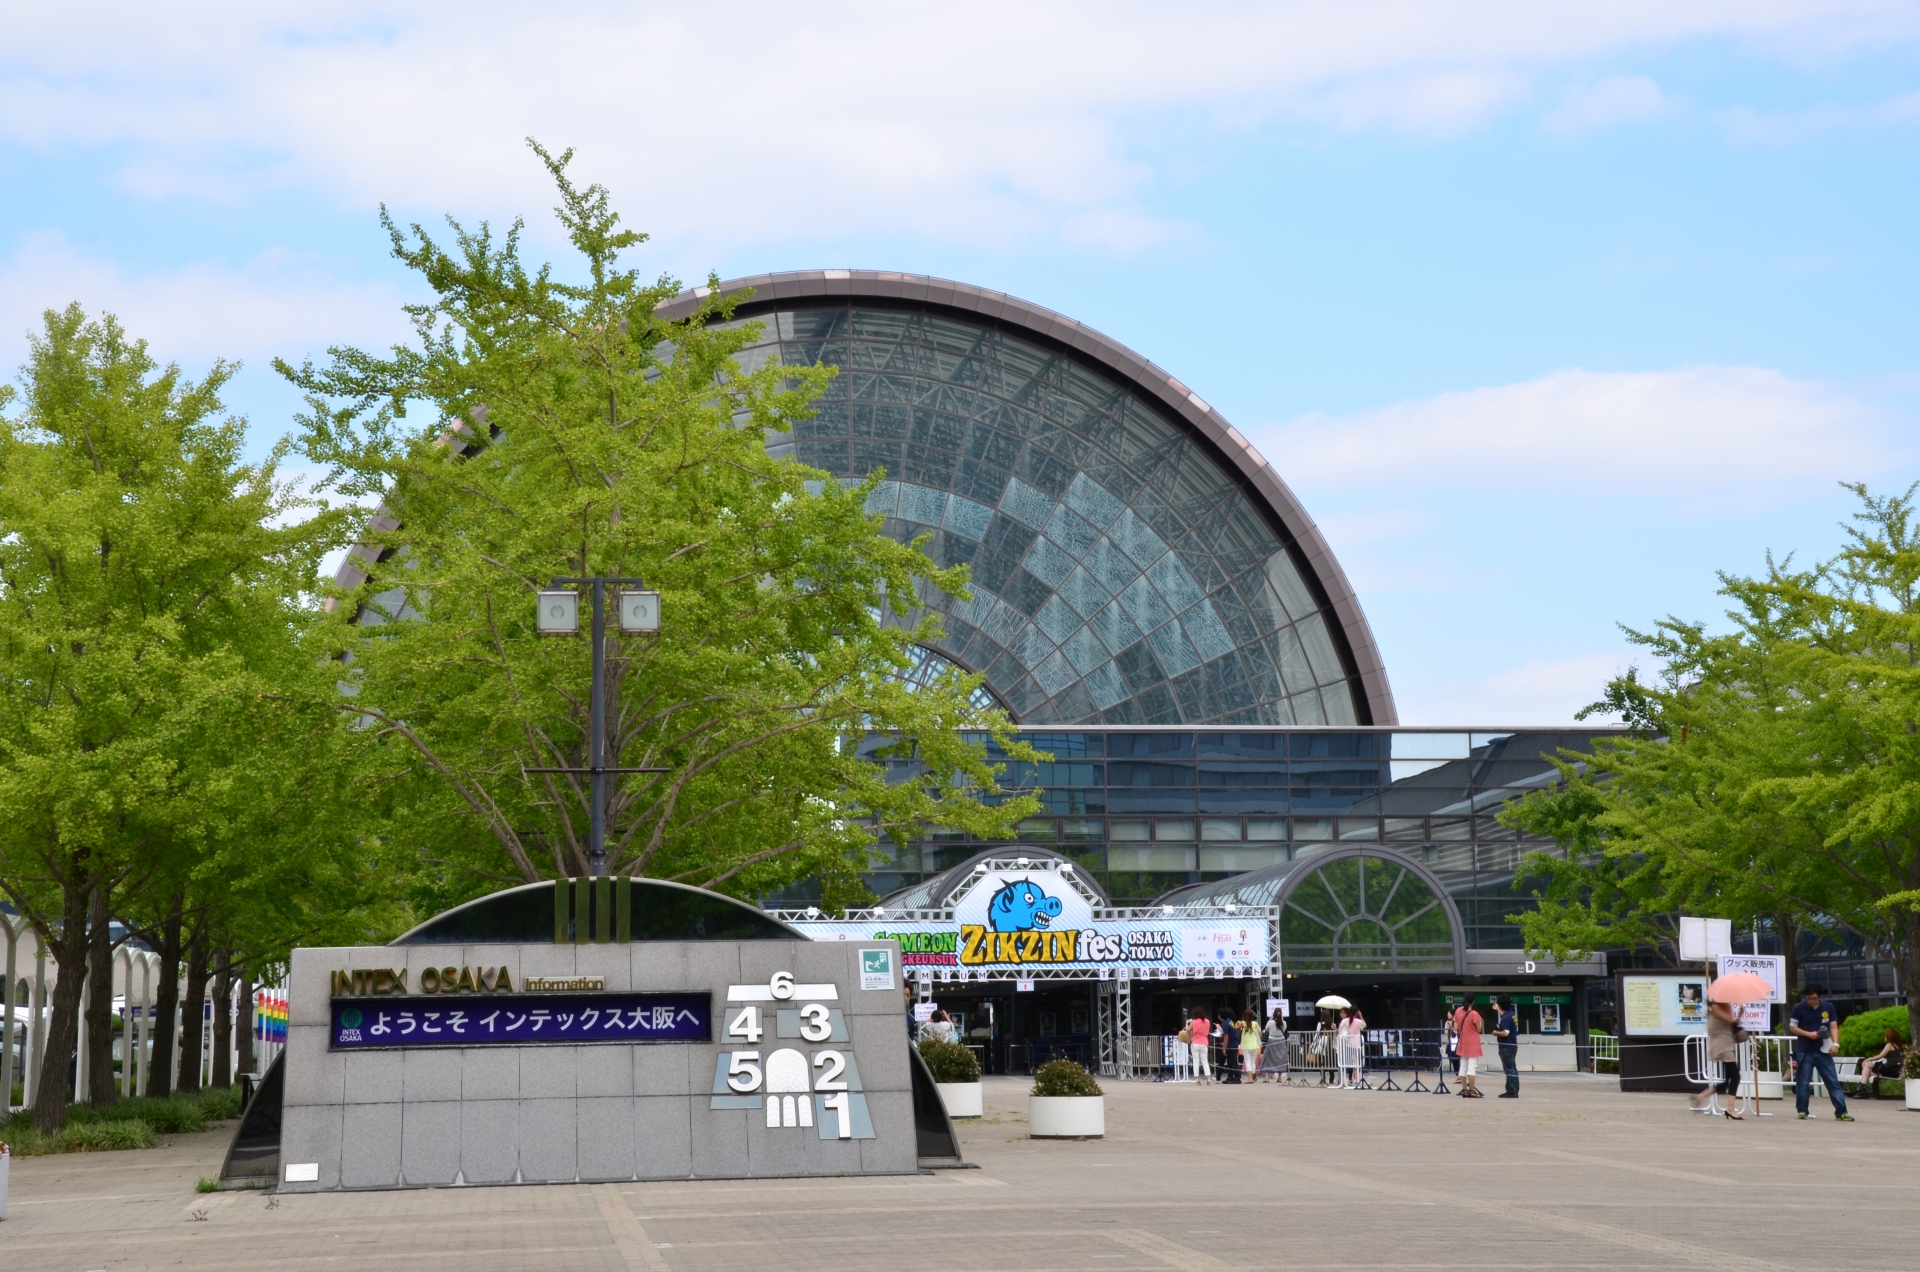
[0,0,1920,724]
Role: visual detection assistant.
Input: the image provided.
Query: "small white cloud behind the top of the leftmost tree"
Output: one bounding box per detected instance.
[0,232,407,371]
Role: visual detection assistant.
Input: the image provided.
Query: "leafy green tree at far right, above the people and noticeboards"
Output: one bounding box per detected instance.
[1505,486,1920,1045]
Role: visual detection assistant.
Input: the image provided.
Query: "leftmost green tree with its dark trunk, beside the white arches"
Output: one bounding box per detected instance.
[0,306,349,1132]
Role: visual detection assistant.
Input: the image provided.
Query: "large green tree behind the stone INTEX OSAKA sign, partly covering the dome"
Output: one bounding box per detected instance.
[280,146,1037,918]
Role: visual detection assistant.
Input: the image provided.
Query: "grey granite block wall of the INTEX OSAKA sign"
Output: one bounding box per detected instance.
[280,942,918,1191]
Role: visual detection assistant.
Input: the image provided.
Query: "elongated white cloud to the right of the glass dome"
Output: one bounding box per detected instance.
[1246,367,1912,509]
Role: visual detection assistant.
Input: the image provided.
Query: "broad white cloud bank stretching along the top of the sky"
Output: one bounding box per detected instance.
[0,0,1920,259]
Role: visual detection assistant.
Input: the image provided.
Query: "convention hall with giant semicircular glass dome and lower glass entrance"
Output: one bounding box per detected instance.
[664,269,1893,1066]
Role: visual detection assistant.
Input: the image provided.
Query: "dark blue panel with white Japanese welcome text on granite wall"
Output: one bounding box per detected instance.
[330,993,712,1051]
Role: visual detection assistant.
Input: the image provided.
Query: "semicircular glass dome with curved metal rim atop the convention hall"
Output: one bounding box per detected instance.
[660,269,1398,726]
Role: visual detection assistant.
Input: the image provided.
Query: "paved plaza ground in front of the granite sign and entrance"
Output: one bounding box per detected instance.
[0,1076,1920,1272]
